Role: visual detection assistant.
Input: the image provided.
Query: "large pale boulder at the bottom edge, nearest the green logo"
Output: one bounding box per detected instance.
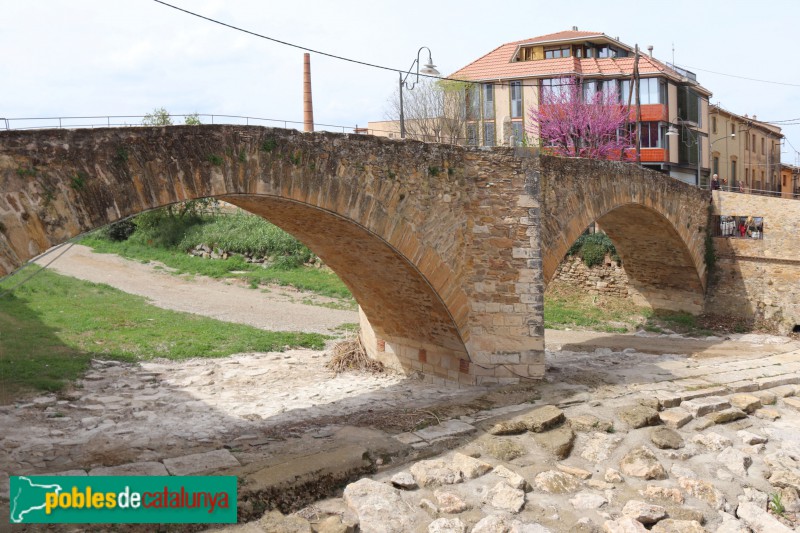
[343,478,414,533]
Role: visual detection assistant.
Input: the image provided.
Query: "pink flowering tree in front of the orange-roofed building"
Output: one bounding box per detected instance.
[529,78,634,159]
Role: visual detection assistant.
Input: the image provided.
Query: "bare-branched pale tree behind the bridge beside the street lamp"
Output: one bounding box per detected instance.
[386,79,467,144]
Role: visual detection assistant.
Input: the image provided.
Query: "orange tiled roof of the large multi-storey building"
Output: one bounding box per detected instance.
[449,31,705,92]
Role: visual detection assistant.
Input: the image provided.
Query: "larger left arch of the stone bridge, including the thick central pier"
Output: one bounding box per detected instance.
[0,126,544,384]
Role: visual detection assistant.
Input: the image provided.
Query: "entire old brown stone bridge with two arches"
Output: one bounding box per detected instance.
[0,126,710,384]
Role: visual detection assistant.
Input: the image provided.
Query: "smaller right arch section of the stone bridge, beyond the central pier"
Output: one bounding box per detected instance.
[541,157,710,312]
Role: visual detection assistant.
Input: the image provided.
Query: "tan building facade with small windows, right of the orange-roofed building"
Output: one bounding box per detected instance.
[709,105,784,195]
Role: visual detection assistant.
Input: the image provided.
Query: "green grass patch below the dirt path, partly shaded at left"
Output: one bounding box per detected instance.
[0,271,328,401]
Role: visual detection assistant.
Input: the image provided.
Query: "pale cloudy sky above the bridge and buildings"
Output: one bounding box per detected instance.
[0,0,800,164]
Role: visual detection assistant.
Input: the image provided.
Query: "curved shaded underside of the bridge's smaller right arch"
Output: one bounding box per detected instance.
[547,204,704,313]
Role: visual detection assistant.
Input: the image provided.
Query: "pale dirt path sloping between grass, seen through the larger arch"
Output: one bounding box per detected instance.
[40,244,358,334]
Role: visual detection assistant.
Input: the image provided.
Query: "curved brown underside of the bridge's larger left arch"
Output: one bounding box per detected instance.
[220,195,469,359]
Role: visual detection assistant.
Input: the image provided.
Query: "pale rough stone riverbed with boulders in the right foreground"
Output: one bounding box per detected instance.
[208,338,800,533]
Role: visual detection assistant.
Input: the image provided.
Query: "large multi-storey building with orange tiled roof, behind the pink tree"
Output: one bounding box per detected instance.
[450,28,711,184]
